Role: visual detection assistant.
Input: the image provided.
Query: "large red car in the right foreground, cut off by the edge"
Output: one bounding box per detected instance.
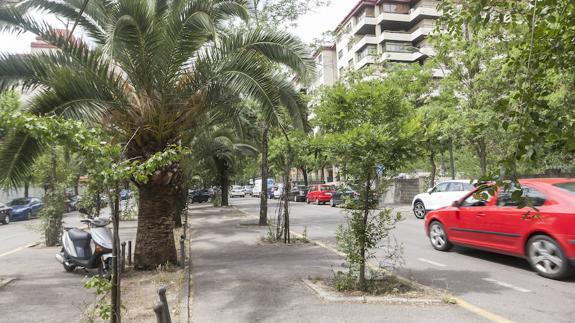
[425,178,575,279]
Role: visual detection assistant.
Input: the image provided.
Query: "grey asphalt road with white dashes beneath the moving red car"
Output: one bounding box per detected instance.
[231,198,575,322]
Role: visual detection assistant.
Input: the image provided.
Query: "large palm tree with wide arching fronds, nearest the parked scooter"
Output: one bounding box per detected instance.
[0,0,312,269]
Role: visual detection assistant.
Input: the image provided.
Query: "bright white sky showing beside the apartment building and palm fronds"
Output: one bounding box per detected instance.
[0,0,357,53]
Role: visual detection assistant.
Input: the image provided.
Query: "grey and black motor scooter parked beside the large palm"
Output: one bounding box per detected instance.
[56,218,114,278]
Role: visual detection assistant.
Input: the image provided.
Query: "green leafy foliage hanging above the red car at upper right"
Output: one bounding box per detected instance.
[441,0,575,177]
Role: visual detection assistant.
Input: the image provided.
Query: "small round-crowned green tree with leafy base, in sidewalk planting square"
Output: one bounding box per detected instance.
[314,69,420,289]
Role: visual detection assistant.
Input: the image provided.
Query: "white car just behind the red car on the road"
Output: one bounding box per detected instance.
[411,180,474,219]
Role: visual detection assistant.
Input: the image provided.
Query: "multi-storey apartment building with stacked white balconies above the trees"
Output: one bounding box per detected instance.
[335,0,440,75]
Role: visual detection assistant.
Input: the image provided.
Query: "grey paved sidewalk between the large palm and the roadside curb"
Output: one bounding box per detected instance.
[190,206,483,323]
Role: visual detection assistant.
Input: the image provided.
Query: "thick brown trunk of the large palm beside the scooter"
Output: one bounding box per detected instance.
[134,181,178,270]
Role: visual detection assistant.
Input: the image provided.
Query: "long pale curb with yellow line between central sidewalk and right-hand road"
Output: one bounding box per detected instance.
[232,206,514,323]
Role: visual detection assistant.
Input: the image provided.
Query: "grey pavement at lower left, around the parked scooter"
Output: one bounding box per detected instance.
[0,215,137,323]
